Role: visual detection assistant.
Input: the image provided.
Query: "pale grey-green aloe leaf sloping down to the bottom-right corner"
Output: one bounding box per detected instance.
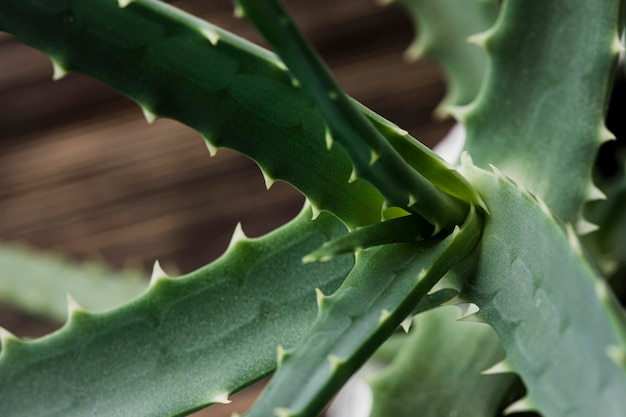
[461,165,626,417]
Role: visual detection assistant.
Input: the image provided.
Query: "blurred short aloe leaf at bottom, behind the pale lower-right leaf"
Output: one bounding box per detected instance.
[370,306,515,417]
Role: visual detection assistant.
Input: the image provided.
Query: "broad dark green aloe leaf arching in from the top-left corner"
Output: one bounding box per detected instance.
[0,0,380,227]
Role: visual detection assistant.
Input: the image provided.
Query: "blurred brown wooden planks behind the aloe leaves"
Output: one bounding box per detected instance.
[0,0,450,415]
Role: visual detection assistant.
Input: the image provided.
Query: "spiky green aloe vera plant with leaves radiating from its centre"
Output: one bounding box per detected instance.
[0,0,626,417]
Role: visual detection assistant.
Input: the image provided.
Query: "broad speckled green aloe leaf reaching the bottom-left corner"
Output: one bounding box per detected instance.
[0,210,353,417]
